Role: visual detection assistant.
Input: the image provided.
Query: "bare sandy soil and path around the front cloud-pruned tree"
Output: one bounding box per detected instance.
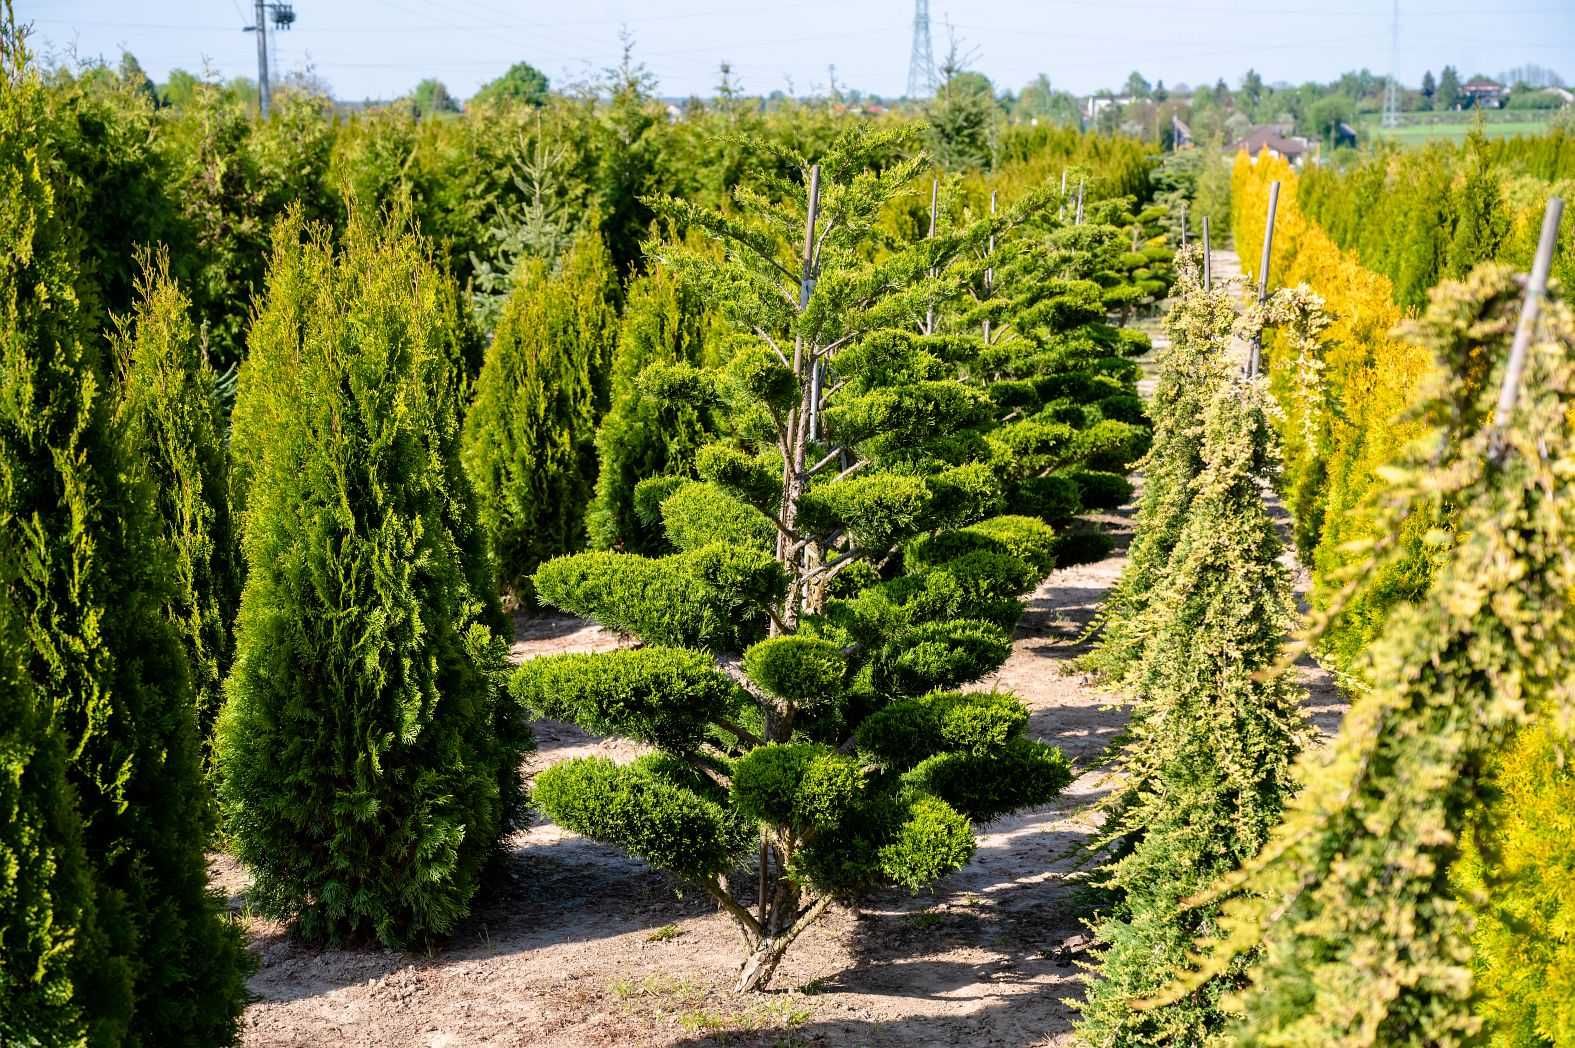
[214,248,1339,1048]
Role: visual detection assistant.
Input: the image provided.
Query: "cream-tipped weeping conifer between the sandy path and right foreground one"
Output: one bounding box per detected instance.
[1079,371,1307,1046]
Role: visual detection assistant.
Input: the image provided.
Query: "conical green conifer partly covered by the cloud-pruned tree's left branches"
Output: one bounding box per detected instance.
[586,268,718,553]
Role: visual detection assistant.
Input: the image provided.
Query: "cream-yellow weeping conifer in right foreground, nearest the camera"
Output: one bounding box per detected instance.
[1175,266,1575,1048]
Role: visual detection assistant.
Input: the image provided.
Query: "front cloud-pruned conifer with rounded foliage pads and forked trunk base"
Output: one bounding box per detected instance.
[512,126,1069,990]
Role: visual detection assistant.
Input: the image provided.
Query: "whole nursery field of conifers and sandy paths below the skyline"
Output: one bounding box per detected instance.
[0,3,1575,1048]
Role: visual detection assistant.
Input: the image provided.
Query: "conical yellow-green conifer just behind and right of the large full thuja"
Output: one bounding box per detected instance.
[463,229,617,599]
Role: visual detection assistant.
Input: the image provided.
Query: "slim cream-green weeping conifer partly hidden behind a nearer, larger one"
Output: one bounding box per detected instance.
[1084,247,1236,681]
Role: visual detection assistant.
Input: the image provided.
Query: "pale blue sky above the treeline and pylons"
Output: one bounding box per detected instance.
[16,0,1575,99]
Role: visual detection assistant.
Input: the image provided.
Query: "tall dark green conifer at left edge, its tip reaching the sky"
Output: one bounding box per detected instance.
[0,13,249,1046]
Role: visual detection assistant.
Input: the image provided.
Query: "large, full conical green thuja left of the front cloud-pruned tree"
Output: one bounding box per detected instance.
[217,211,529,946]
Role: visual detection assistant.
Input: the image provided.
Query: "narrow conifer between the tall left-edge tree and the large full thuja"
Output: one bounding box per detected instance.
[115,252,241,775]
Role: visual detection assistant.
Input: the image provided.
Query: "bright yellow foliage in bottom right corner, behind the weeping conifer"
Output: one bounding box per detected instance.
[1455,720,1575,1048]
